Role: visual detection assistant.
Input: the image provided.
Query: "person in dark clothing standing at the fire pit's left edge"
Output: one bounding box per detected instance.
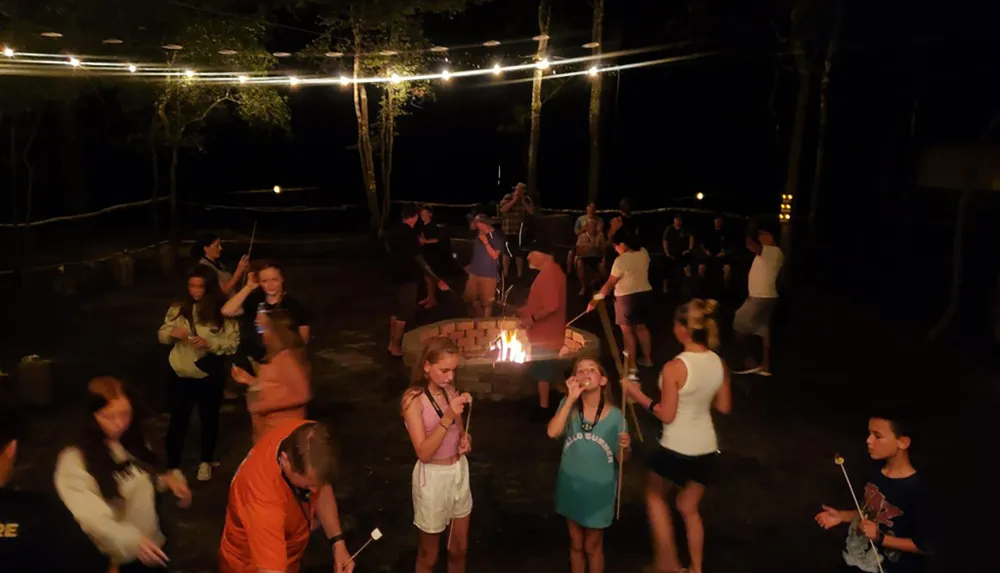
[386,205,449,358]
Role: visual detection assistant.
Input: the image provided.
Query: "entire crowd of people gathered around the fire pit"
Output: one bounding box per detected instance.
[0,191,933,573]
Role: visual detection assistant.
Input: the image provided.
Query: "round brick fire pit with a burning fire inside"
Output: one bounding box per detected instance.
[403,317,600,400]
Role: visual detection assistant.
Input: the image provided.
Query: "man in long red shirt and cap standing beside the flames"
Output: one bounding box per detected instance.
[517,241,566,422]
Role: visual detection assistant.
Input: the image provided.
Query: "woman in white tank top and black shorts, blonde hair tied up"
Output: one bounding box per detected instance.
[622,298,733,573]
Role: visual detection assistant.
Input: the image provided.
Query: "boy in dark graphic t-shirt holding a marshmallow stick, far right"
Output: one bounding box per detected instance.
[816,414,934,573]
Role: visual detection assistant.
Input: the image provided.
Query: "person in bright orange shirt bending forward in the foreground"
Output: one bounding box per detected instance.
[219,420,354,573]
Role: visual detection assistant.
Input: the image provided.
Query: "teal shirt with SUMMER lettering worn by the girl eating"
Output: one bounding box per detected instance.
[556,399,628,529]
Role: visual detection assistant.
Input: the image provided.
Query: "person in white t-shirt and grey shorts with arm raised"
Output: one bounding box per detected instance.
[733,223,785,376]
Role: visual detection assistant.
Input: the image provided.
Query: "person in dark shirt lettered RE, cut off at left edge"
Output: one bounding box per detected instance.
[0,407,111,573]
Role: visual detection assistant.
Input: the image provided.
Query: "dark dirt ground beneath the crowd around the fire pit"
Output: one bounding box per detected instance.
[0,238,998,573]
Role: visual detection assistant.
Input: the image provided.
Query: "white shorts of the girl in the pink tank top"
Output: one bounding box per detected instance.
[413,456,472,534]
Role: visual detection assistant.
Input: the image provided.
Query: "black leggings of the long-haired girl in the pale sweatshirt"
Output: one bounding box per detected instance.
[167,369,225,469]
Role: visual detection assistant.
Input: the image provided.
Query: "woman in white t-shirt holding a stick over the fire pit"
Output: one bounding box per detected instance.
[587,231,653,372]
